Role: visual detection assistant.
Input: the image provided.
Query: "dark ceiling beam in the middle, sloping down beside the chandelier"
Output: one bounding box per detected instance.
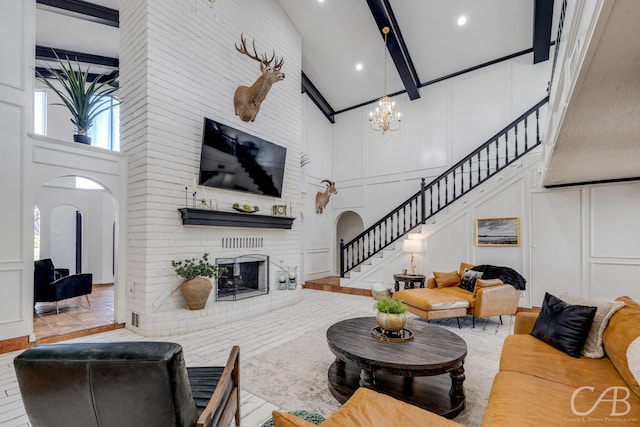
[367,0,420,100]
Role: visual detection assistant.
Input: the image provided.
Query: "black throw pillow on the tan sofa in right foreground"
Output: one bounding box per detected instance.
[531,293,596,357]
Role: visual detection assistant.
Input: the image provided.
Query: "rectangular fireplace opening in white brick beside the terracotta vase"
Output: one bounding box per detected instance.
[216,255,269,301]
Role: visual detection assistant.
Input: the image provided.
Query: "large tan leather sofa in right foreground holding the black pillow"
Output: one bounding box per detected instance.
[482,297,640,427]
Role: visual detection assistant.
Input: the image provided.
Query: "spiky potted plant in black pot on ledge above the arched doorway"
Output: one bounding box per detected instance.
[36,51,118,144]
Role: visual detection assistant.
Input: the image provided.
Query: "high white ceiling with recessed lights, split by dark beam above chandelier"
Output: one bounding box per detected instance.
[278,0,560,111]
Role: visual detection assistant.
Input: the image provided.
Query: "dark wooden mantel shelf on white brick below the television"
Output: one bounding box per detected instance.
[178,208,295,230]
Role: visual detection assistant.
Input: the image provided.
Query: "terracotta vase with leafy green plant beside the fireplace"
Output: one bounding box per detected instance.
[171,253,227,310]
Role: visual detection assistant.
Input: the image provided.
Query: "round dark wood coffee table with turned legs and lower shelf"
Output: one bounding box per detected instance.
[327,317,467,418]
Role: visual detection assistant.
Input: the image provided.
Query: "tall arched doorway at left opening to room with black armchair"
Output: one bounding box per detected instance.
[34,176,117,341]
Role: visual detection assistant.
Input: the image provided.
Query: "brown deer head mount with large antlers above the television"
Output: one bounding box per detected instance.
[233,34,284,122]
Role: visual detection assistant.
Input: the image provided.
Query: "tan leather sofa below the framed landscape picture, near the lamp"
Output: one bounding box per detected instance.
[393,263,520,326]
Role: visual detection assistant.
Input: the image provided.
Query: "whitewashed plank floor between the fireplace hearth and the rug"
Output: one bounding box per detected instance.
[0,289,373,427]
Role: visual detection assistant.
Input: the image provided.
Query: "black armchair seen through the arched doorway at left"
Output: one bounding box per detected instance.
[33,258,93,313]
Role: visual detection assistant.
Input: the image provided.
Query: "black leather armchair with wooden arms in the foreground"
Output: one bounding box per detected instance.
[14,341,240,427]
